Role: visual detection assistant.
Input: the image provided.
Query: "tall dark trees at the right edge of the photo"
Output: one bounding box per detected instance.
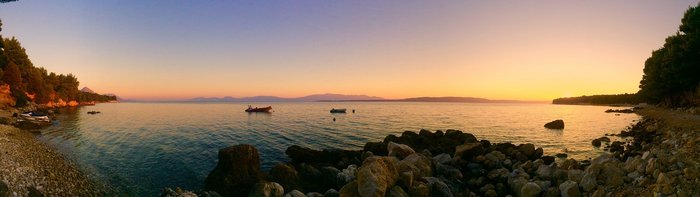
[638,4,700,106]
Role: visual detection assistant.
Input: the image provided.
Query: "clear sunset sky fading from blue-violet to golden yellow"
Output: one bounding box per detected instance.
[0,0,697,100]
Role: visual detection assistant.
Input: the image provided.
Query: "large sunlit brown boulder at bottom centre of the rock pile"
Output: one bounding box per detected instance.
[357,156,399,197]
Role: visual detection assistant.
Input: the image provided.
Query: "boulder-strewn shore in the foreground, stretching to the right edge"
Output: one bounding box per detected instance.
[161,108,700,197]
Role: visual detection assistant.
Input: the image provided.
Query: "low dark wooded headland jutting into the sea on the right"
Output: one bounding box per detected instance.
[552,94,641,105]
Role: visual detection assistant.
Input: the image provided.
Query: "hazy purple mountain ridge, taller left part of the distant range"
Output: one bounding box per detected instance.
[189,94,383,102]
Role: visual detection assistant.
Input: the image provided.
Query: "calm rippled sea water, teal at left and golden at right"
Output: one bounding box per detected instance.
[39,102,639,196]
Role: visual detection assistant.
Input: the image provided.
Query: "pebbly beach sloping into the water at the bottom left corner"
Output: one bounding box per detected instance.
[0,125,104,197]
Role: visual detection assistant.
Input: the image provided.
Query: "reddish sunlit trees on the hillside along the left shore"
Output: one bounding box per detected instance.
[0,21,116,106]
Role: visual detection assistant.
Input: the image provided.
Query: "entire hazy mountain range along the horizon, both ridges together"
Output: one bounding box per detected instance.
[188,94,548,103]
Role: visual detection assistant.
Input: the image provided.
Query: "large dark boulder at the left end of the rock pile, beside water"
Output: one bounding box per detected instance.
[204,144,260,196]
